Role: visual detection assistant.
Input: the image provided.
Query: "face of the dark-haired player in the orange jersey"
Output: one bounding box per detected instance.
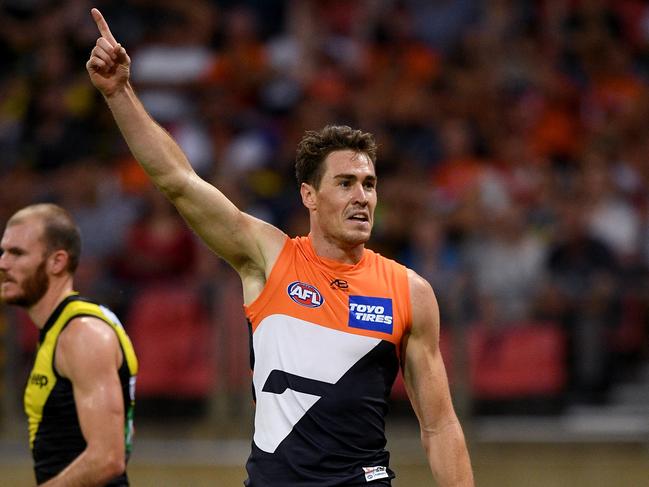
[308,150,376,247]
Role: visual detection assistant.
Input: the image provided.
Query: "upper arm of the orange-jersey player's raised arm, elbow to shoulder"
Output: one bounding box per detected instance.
[171,174,286,270]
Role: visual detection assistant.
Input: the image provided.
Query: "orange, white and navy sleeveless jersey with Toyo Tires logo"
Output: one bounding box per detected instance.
[244,237,412,487]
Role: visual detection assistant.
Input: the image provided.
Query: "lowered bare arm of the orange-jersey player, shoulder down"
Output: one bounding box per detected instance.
[403,270,474,487]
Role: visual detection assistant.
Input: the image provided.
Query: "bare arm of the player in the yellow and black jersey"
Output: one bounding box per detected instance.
[43,317,126,487]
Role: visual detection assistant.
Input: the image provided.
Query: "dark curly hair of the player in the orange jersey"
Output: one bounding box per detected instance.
[295,125,376,189]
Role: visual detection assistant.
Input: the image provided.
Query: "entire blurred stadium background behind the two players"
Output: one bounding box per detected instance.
[0,0,649,487]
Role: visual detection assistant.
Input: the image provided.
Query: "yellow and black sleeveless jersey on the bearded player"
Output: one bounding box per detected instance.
[24,293,138,486]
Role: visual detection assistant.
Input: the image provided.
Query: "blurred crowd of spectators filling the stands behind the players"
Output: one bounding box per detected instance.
[0,0,649,412]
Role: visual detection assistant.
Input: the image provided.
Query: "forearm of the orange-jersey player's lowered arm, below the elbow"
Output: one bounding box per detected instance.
[421,421,474,487]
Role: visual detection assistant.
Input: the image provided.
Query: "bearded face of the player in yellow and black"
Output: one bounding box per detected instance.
[0,221,49,308]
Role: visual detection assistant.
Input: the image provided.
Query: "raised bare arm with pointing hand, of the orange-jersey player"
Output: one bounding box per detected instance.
[86,9,286,294]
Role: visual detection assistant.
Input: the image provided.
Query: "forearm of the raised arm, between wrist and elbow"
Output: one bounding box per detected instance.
[105,83,193,197]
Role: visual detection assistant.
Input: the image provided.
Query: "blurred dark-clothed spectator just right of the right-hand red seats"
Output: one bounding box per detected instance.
[546,196,620,402]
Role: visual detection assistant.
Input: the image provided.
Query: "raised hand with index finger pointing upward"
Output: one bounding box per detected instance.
[86,8,131,96]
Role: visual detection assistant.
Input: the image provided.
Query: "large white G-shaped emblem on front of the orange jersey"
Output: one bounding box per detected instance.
[253,314,381,453]
